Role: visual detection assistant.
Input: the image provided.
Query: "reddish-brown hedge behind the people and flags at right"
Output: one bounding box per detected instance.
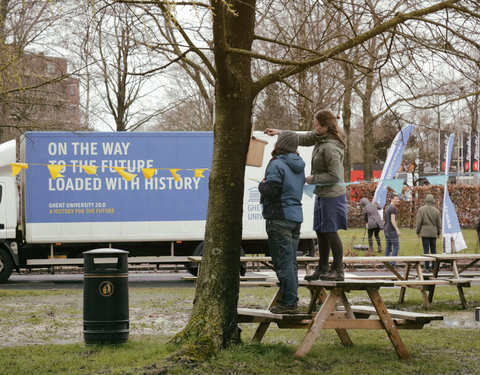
[347,183,480,229]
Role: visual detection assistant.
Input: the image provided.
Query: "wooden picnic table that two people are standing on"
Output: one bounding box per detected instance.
[238,279,443,359]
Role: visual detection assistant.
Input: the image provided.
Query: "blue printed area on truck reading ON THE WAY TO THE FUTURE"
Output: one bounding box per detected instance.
[22,132,213,223]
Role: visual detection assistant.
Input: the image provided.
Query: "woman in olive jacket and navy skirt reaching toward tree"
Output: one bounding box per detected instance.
[265,109,347,281]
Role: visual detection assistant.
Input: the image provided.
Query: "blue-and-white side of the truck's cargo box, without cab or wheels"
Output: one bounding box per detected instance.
[22,132,315,244]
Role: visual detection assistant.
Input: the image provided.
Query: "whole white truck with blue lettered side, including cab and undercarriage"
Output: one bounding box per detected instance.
[0,132,315,282]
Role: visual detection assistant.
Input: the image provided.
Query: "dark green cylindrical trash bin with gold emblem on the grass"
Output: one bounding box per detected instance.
[83,249,130,344]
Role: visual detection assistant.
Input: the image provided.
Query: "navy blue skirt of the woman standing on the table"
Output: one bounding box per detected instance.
[313,194,347,232]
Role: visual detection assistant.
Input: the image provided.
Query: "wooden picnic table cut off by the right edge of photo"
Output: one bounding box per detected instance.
[427,253,480,309]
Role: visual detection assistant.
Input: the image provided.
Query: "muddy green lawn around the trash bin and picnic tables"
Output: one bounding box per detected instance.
[0,274,480,375]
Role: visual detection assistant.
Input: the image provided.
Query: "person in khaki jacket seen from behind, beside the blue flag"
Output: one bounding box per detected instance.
[415,194,442,271]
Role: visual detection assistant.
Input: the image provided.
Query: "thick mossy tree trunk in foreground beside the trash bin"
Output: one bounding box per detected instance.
[174,0,255,354]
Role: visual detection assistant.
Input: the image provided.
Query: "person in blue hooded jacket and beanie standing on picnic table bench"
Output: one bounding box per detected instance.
[258,131,305,314]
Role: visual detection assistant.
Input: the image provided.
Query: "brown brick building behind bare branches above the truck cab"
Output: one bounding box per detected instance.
[0,49,84,142]
